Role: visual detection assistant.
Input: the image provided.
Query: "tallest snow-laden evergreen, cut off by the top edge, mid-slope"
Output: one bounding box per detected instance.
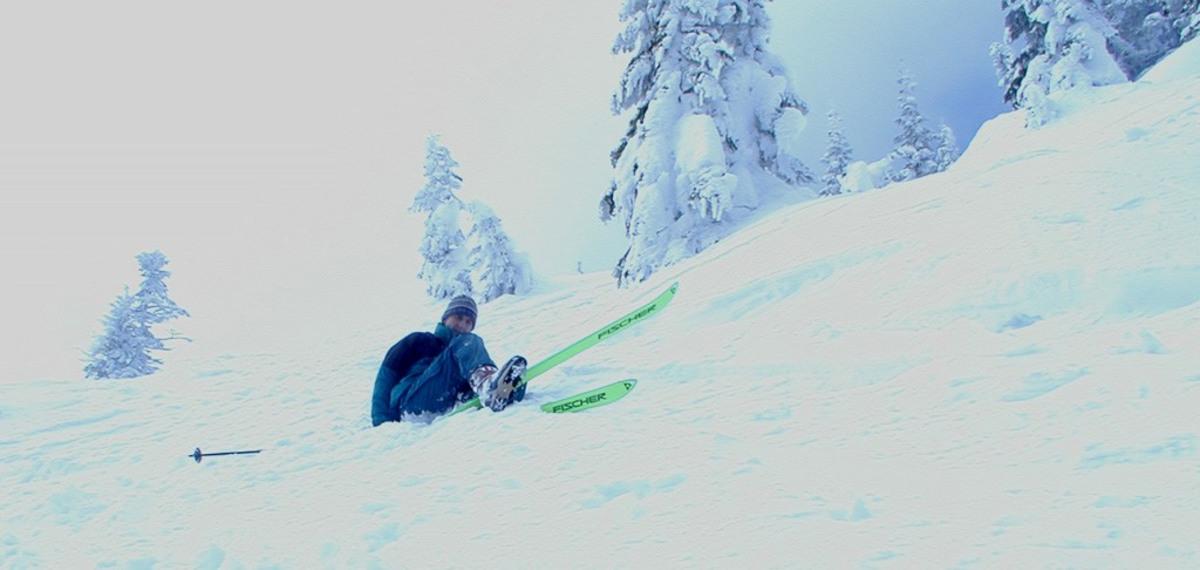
[600,0,812,286]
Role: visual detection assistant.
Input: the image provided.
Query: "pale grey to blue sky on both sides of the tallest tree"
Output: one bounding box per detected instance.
[0,0,1004,379]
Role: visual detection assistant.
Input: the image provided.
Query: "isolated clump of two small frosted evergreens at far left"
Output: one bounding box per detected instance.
[84,251,187,378]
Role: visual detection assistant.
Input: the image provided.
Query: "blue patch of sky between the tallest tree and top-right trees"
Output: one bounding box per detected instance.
[769,0,1012,162]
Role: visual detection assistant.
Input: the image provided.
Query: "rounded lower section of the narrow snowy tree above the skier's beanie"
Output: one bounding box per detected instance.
[418,199,473,299]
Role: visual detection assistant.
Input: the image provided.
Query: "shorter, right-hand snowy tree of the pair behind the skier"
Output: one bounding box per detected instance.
[468,202,532,302]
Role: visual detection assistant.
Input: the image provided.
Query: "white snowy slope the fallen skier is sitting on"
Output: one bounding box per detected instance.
[0,42,1200,569]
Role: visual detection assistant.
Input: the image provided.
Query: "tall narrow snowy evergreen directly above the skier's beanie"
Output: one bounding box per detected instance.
[410,136,473,299]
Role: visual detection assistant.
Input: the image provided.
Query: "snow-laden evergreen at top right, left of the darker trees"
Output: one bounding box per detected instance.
[991,0,1127,126]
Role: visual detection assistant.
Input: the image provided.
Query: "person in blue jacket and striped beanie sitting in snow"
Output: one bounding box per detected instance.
[371,295,526,426]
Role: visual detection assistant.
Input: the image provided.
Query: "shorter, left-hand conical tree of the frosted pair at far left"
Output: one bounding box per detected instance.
[83,289,166,379]
